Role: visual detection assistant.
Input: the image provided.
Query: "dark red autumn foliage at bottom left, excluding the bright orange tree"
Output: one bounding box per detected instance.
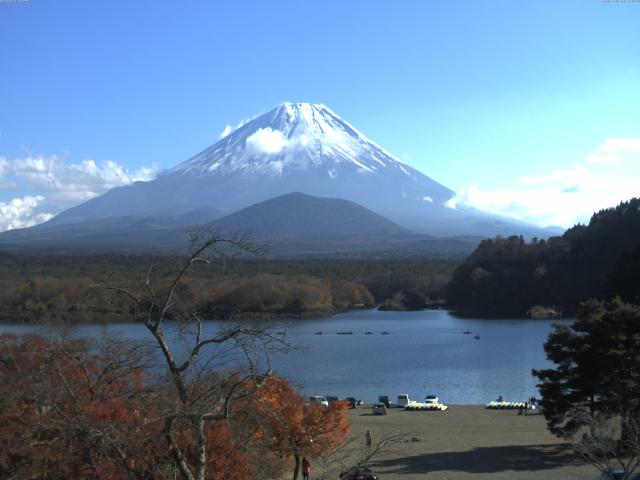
[0,335,251,480]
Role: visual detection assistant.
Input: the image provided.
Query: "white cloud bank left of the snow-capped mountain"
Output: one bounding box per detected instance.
[0,155,160,231]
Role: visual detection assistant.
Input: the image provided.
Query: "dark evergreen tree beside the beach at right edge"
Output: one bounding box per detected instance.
[533,299,640,437]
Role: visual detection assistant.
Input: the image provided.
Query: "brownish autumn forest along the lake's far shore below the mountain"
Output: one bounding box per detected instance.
[0,253,455,322]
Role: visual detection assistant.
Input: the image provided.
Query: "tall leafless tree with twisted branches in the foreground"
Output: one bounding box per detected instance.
[111,231,282,480]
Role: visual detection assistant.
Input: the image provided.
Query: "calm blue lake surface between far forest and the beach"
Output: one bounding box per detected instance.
[0,310,571,404]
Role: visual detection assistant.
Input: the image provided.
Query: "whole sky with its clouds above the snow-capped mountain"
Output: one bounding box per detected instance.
[0,0,640,230]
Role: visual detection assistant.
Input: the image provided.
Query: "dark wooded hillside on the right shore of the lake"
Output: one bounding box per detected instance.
[447,198,640,316]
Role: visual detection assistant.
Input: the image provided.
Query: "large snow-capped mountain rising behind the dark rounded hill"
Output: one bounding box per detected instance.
[0,103,550,251]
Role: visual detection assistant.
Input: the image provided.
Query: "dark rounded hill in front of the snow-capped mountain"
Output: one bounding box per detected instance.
[210,193,480,258]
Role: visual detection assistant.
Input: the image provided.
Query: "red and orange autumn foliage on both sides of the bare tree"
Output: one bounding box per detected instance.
[0,335,349,480]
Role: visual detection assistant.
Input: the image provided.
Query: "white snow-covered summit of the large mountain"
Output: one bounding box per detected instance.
[168,102,413,178]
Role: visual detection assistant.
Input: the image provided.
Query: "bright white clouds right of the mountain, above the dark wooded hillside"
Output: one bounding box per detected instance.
[446,138,640,227]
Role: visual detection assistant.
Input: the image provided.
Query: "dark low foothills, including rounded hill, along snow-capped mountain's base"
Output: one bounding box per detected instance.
[0,193,480,257]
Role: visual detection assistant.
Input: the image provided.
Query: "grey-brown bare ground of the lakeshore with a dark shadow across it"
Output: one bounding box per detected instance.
[312,406,599,480]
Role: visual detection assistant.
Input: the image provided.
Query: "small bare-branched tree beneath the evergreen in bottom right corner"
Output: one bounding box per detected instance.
[573,414,640,480]
